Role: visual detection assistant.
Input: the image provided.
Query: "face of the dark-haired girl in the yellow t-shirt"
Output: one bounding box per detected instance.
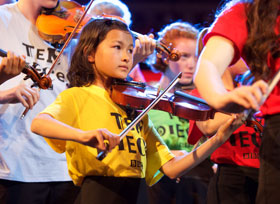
[90,29,133,79]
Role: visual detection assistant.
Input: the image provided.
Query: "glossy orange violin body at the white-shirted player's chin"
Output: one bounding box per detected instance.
[36,1,91,44]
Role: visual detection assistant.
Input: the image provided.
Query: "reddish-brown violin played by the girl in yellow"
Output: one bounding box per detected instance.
[111,80,216,121]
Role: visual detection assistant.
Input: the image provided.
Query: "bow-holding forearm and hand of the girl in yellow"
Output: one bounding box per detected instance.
[31,114,120,151]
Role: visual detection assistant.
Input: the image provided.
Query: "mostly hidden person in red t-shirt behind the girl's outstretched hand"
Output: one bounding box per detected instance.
[188,27,261,204]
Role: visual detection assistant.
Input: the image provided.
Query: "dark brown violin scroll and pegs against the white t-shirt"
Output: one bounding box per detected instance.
[0,49,52,89]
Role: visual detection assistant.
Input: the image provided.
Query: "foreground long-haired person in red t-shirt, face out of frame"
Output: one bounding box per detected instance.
[194,0,280,203]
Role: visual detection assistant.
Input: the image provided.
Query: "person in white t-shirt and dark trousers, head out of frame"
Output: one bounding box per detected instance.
[0,0,78,204]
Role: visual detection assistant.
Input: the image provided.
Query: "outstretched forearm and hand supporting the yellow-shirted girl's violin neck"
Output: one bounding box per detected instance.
[161,116,242,179]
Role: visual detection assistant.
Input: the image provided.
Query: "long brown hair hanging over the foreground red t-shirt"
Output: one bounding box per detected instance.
[218,0,280,80]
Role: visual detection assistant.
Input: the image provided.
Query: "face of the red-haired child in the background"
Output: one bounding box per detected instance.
[169,38,197,84]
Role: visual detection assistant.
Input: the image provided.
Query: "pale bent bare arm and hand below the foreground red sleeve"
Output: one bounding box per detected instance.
[194,36,267,112]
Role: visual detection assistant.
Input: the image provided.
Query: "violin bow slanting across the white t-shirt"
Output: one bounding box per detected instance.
[20,0,94,119]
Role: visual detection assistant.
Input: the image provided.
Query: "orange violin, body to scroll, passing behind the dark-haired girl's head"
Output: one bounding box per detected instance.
[36,1,181,61]
